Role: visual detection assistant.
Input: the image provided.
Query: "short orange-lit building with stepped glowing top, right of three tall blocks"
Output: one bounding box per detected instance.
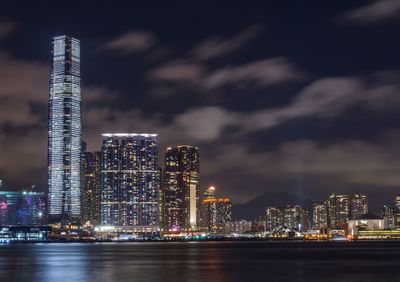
[200,187,232,234]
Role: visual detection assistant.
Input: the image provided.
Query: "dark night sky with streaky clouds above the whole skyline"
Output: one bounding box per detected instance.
[0,0,400,206]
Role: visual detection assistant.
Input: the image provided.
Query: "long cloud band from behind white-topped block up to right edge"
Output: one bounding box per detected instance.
[85,72,400,151]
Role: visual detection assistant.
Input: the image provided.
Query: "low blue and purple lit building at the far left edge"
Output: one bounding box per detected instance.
[0,191,46,226]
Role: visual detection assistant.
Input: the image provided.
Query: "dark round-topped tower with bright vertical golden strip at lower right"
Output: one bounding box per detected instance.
[163,145,200,229]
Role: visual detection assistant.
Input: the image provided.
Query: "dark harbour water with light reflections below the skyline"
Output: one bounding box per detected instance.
[0,242,400,282]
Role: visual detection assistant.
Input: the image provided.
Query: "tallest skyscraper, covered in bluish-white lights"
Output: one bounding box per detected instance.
[48,35,81,225]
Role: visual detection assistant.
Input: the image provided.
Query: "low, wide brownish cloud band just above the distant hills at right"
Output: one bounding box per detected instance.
[202,132,400,202]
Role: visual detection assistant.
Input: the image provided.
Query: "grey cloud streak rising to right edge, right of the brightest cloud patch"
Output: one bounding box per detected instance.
[240,76,400,131]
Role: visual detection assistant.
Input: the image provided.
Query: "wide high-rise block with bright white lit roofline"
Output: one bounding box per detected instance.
[100,133,160,230]
